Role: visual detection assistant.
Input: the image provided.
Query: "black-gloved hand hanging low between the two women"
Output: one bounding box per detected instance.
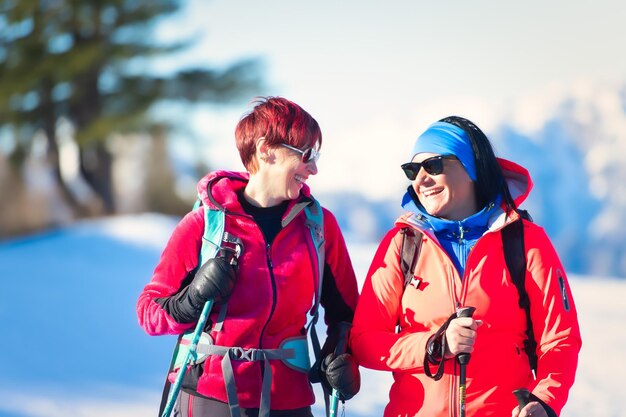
[321,353,361,401]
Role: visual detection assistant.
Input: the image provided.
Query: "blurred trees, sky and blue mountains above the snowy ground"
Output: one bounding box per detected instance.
[0,0,626,277]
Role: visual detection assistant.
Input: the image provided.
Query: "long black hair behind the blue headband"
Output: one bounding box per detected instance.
[439,116,516,213]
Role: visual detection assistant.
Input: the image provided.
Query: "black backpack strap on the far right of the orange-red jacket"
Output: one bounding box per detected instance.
[501,210,538,379]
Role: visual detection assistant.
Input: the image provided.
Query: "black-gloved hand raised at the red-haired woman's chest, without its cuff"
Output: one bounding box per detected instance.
[189,257,237,309]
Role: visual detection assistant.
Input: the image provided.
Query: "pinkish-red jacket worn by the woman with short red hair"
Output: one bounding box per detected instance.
[137,172,358,410]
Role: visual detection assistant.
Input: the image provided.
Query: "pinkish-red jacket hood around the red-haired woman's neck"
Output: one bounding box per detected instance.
[197,170,311,211]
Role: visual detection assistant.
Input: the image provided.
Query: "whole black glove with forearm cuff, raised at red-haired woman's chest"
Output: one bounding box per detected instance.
[160,257,237,323]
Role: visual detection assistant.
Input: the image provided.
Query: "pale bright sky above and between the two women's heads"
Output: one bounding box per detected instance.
[152,0,626,202]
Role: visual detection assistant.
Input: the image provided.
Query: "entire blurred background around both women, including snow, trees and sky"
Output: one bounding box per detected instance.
[0,0,626,417]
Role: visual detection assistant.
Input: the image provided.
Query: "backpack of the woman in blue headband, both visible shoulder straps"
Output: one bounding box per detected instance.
[400,210,537,377]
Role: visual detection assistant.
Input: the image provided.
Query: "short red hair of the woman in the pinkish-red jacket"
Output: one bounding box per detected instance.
[235,97,322,173]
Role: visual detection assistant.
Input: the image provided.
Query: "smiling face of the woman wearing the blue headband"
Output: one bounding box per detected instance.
[411,153,477,221]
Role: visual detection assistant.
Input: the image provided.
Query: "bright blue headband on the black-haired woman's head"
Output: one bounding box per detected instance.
[411,122,476,181]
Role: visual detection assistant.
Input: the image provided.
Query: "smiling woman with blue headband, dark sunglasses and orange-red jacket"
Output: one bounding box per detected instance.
[350,116,581,417]
